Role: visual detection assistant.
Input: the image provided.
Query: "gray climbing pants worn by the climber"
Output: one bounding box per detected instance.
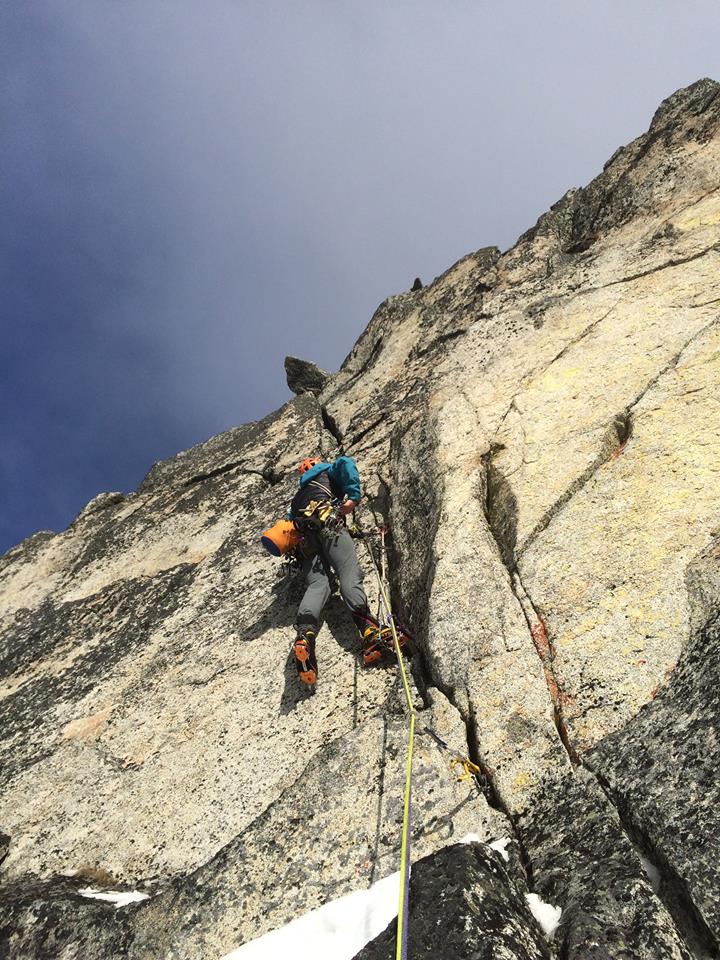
[297,527,368,632]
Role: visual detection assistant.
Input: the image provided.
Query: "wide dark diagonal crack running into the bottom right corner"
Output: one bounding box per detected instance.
[582,763,720,960]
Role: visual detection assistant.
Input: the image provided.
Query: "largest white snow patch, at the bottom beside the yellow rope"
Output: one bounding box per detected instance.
[222,873,400,960]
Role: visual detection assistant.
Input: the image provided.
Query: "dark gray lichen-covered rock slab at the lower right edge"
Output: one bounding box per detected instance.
[588,541,720,953]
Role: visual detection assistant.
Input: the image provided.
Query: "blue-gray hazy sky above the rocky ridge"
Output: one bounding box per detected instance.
[0,0,720,553]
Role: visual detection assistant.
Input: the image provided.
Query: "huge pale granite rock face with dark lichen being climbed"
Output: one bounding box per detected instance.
[0,80,720,960]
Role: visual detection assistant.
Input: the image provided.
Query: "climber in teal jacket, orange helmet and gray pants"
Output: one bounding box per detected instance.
[288,457,396,684]
